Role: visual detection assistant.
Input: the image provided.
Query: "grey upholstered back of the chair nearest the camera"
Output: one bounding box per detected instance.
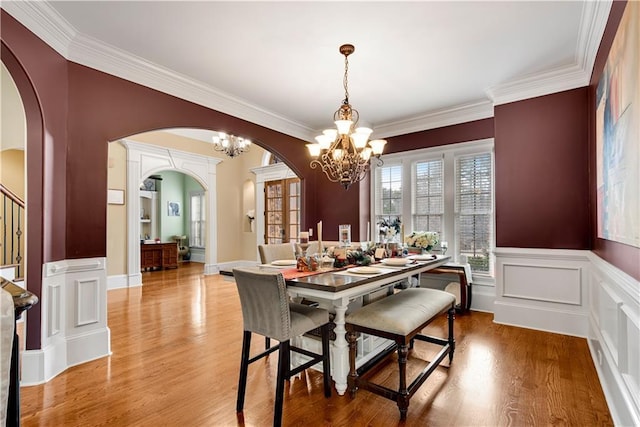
[233,268,291,341]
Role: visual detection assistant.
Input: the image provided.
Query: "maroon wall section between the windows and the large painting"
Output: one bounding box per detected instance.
[494,88,590,249]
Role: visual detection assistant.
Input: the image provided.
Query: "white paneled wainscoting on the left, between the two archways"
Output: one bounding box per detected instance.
[21,258,111,386]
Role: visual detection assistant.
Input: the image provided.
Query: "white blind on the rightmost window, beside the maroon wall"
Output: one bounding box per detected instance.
[455,153,493,273]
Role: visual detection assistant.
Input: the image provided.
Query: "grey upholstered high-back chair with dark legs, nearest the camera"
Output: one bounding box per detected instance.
[233,268,331,426]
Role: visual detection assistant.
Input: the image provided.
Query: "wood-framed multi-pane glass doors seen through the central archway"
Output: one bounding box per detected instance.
[264,178,300,244]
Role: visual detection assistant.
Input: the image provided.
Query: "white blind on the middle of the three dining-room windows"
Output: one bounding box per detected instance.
[413,159,444,235]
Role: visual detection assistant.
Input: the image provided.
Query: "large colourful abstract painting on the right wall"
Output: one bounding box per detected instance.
[596,2,640,247]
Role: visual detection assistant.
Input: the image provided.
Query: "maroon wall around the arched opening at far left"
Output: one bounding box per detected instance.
[0,10,68,349]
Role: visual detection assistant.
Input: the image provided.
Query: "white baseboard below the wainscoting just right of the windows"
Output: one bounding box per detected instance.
[492,296,588,338]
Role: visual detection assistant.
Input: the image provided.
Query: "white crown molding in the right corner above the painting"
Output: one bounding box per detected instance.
[486,0,611,105]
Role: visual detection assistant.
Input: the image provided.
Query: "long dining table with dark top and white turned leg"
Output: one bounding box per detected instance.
[260,254,451,395]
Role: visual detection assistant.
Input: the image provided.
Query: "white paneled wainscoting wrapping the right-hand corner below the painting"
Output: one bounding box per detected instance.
[496,248,640,426]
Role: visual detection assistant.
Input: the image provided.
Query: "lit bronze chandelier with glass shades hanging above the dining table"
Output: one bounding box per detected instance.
[307,44,387,189]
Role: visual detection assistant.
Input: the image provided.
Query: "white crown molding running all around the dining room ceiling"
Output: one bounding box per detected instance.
[2,0,612,137]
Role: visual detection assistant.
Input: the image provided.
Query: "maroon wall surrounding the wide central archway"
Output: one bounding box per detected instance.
[66,63,316,258]
